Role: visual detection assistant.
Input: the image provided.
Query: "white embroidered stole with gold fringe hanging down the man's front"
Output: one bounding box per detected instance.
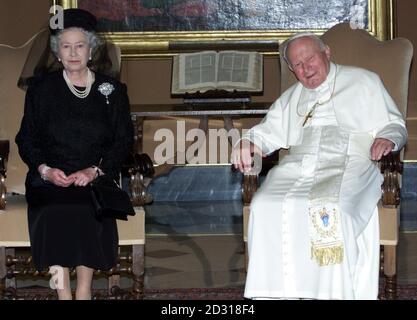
[308,126,349,266]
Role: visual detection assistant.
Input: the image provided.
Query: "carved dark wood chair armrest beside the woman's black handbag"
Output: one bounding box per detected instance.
[122,153,155,206]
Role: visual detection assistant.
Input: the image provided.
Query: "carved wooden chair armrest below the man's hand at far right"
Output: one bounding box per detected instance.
[379,152,403,207]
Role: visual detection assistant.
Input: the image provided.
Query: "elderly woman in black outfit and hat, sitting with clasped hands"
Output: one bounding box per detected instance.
[16,9,133,299]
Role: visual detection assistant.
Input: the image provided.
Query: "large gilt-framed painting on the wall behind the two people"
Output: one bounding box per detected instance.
[53,0,393,57]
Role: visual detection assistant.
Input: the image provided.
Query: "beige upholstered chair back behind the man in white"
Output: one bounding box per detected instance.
[281,23,413,117]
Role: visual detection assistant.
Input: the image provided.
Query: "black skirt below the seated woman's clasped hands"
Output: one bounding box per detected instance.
[26,182,118,271]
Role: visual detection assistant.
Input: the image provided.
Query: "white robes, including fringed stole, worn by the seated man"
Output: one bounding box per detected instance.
[243,63,407,299]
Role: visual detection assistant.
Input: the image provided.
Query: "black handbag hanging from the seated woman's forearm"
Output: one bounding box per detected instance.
[90,176,135,220]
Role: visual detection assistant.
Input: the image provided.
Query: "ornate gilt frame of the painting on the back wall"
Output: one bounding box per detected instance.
[52,0,394,59]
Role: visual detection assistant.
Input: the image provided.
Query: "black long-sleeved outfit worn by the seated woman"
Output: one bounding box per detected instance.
[16,71,133,270]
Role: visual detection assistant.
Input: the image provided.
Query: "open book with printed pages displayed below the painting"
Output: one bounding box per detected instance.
[171,51,263,95]
